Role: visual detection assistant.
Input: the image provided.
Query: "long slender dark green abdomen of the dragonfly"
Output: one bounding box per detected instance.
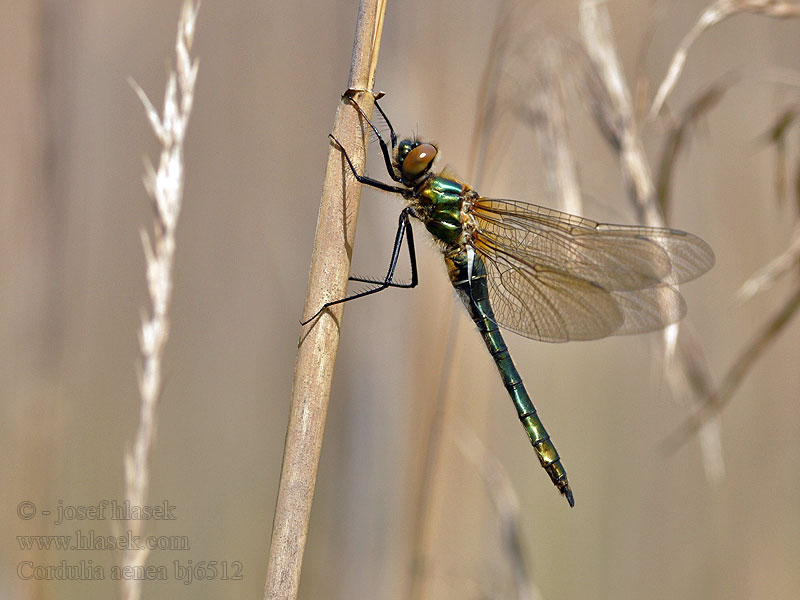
[445,248,574,506]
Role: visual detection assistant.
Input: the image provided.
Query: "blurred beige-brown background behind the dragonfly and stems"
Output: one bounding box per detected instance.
[0,0,800,600]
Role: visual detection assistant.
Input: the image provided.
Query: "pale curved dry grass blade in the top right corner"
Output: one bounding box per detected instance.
[648,0,800,119]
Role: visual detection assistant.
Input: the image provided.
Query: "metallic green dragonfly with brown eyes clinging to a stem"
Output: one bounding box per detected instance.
[302,91,714,506]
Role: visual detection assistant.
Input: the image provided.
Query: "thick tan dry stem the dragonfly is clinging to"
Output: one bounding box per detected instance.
[264,0,386,600]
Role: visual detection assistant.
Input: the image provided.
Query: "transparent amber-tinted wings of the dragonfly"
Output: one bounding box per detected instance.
[470,198,714,342]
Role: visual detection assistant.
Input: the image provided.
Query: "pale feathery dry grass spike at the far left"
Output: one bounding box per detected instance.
[121,0,198,600]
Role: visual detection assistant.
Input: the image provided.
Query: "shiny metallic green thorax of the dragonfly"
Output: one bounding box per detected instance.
[413,175,471,245]
